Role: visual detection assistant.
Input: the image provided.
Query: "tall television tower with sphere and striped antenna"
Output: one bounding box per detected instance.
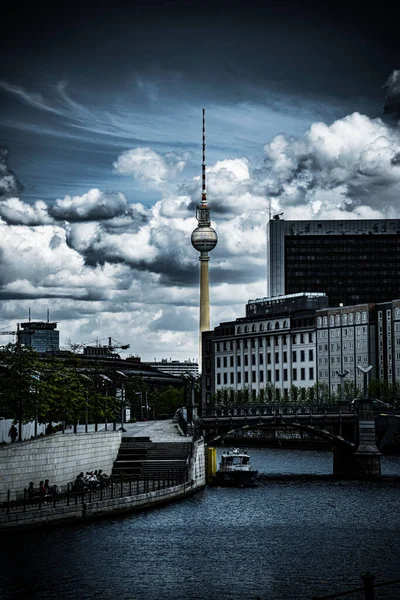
[192,108,218,372]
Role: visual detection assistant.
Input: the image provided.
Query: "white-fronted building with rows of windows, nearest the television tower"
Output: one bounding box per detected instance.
[203,294,328,404]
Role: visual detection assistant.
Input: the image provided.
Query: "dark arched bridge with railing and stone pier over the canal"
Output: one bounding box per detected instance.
[188,398,400,477]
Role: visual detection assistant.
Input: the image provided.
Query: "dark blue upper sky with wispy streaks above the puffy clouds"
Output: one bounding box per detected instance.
[0,0,399,203]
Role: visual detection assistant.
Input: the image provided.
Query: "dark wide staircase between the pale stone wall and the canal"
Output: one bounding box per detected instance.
[112,437,191,477]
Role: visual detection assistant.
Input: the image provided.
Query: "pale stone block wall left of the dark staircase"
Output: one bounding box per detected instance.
[0,431,121,495]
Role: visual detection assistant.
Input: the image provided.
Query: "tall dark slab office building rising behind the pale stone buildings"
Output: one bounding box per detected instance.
[267,218,400,306]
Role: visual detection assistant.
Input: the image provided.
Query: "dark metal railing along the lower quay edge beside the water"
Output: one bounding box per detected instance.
[0,467,188,515]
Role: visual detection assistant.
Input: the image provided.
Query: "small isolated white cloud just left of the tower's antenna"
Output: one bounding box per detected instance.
[114,147,188,188]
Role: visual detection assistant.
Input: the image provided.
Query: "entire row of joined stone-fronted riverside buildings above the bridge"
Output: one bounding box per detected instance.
[202,293,400,404]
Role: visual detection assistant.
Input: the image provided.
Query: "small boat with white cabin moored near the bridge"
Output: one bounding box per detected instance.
[215,448,258,487]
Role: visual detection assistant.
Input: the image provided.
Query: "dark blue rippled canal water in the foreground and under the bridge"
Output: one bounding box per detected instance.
[0,448,400,600]
